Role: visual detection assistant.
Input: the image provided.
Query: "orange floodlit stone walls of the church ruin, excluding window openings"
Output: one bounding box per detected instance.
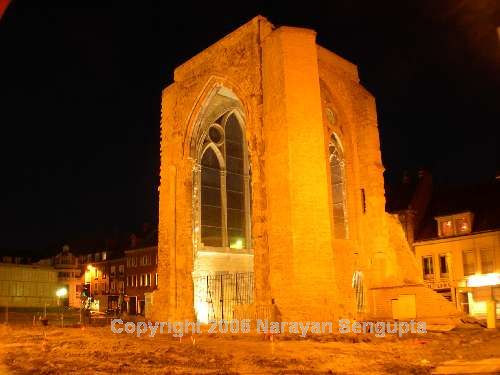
[151,16,458,320]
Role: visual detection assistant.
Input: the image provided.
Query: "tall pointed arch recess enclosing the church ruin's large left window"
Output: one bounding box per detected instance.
[189,86,251,252]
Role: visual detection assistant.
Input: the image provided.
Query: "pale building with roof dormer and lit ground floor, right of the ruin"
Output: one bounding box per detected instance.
[391,177,500,318]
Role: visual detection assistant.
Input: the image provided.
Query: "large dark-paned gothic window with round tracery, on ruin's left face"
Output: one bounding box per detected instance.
[195,110,251,249]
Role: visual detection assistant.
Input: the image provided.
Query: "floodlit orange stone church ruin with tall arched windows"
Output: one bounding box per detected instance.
[149,16,456,322]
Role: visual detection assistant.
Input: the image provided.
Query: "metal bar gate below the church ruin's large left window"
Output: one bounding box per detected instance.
[193,272,254,323]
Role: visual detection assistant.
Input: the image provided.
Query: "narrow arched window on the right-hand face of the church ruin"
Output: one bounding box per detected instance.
[328,134,348,238]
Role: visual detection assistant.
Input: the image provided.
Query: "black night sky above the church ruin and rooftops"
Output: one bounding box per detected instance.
[0,0,500,252]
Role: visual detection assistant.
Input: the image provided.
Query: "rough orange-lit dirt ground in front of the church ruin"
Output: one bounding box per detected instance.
[0,324,500,374]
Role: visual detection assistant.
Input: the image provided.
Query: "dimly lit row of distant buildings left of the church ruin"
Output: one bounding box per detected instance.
[0,224,158,315]
